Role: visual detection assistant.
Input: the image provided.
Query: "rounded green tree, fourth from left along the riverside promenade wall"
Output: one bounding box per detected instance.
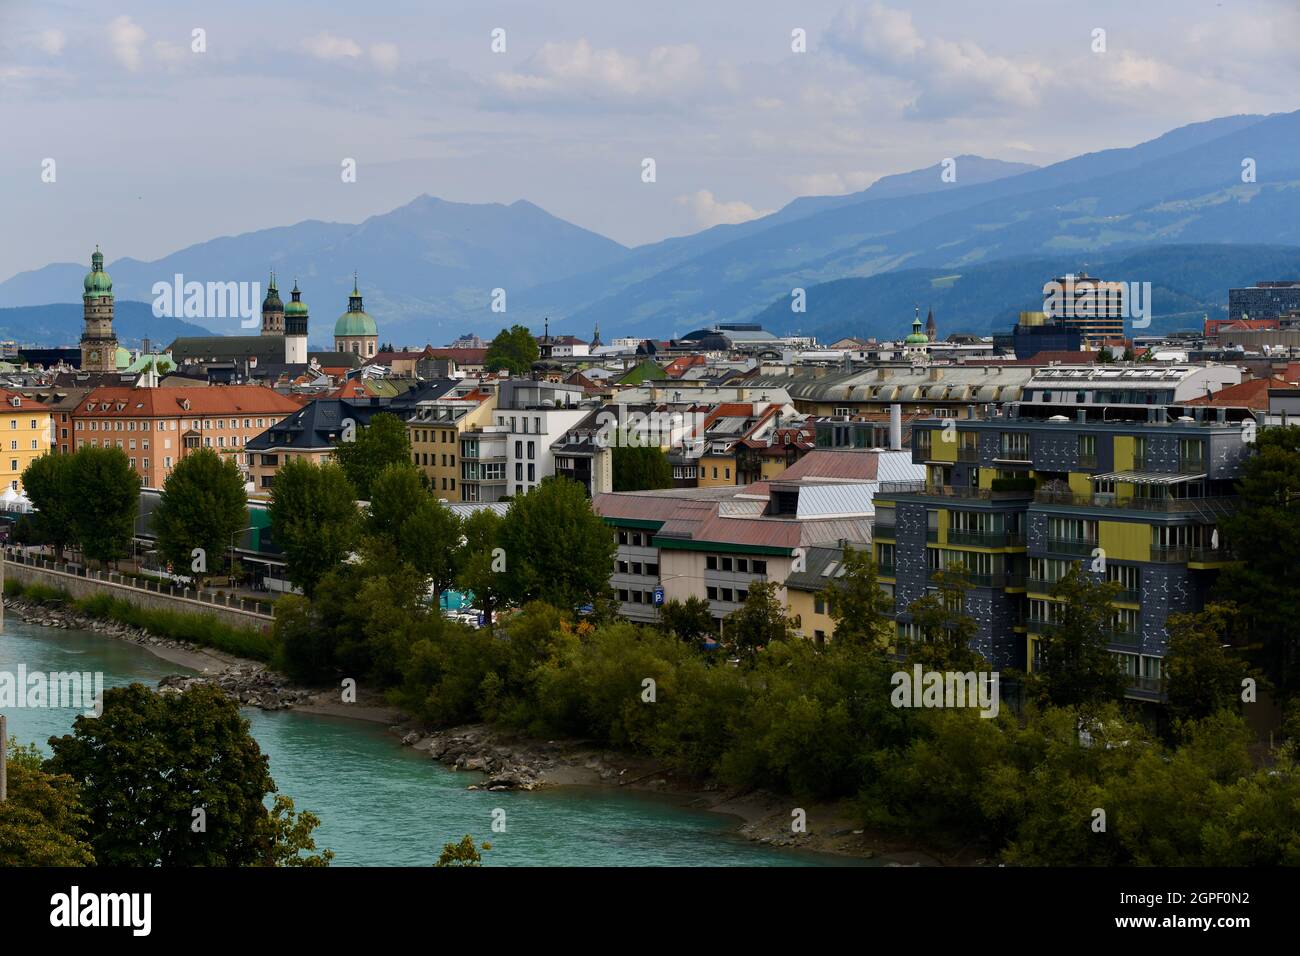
[270,458,360,597]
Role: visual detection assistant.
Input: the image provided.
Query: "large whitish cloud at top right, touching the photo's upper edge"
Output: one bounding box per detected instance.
[828,3,1050,118]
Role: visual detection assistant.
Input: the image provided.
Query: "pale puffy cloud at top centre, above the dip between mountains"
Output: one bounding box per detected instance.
[491,39,701,103]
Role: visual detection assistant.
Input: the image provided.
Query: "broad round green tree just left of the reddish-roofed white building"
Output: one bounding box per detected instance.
[499,477,616,610]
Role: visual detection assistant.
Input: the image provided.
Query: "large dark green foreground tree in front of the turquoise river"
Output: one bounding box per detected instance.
[46,684,322,866]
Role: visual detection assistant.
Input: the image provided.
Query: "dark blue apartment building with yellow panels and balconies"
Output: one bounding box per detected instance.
[875,403,1253,700]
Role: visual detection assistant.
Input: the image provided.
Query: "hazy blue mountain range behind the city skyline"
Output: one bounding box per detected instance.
[0,111,1300,345]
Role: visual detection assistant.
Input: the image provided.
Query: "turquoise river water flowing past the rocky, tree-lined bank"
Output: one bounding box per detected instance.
[0,615,854,866]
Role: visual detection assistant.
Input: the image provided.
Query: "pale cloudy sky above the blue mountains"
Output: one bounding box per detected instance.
[0,0,1300,280]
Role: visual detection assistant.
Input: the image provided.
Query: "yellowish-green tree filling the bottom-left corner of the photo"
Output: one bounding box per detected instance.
[0,737,95,866]
